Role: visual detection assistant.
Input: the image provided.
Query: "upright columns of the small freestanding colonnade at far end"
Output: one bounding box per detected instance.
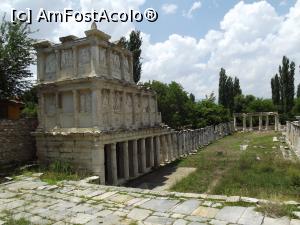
[233,114,279,131]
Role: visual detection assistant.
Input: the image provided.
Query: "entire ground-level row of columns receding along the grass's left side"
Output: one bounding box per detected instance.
[100,123,233,185]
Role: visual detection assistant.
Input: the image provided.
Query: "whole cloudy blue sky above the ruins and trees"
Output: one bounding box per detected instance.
[0,0,300,99]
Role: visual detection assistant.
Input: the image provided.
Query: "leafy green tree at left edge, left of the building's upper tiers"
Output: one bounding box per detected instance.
[0,17,35,99]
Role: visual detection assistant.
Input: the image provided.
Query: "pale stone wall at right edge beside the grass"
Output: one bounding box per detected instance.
[285,121,300,158]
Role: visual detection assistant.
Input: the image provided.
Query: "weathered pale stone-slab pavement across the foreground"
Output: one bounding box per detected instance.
[0,174,300,225]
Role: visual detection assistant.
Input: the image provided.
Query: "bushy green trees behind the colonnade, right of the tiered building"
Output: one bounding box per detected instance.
[144,81,229,129]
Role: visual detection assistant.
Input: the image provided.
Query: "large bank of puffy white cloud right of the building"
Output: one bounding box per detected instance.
[143,0,300,98]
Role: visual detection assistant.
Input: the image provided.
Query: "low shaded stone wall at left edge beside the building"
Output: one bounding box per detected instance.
[0,119,37,173]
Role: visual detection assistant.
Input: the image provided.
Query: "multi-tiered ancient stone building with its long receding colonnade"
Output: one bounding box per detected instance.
[34,22,233,185]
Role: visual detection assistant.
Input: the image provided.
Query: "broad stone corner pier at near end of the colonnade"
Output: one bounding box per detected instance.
[92,140,105,185]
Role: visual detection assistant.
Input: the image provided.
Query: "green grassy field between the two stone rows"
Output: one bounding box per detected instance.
[172,131,300,201]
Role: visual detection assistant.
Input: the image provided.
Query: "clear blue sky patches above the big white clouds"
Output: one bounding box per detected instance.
[136,0,296,42]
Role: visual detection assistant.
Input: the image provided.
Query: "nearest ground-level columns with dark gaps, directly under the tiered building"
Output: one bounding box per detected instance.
[101,136,160,185]
